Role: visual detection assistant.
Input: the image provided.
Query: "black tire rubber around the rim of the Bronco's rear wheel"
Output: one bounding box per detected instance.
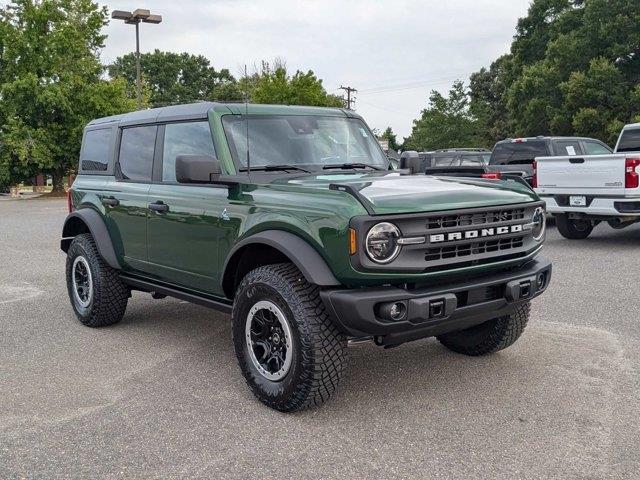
[66,233,130,327]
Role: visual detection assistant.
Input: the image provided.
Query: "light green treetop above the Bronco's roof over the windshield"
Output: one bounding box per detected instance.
[248,60,344,107]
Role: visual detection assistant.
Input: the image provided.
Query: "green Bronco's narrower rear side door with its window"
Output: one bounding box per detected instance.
[100,125,158,271]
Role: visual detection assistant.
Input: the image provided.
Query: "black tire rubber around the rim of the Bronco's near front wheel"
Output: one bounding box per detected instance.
[232,263,347,412]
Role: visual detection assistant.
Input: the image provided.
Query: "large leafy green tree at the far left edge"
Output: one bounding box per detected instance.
[0,0,135,190]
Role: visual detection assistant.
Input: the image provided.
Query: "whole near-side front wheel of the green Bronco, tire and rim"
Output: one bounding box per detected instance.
[232,263,347,412]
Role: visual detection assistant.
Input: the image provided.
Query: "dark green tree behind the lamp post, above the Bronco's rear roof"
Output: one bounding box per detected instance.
[108,50,243,107]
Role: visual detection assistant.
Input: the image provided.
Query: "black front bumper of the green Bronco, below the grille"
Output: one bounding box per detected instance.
[320,258,551,345]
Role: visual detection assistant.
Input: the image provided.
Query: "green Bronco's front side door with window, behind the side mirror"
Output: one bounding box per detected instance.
[148,120,229,295]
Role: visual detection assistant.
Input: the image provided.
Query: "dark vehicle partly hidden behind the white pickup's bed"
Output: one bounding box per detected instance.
[487,136,611,184]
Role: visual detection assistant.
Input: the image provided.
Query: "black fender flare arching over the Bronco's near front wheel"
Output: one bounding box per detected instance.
[222,230,341,287]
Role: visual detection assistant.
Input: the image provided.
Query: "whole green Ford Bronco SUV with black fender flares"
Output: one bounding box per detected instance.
[61,103,551,411]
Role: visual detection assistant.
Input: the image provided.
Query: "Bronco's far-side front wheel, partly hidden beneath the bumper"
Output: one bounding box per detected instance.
[437,302,530,356]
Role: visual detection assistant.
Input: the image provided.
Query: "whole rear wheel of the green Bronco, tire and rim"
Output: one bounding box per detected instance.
[66,233,129,327]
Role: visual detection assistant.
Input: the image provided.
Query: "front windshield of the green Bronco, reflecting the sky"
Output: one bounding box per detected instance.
[222,115,388,169]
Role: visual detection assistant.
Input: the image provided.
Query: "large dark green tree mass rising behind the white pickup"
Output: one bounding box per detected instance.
[470,0,640,143]
